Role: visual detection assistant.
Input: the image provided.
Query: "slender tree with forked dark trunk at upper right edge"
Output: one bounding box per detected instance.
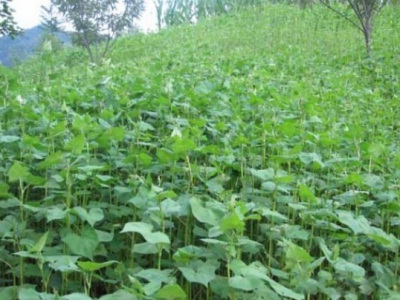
[320,0,388,56]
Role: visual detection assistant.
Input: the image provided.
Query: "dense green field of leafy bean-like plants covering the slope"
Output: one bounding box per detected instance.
[0,4,400,300]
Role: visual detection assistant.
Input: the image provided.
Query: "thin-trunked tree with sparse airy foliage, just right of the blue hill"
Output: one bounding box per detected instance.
[51,0,144,63]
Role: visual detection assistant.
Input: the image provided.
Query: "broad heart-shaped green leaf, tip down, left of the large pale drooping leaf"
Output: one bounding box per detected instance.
[62,227,99,260]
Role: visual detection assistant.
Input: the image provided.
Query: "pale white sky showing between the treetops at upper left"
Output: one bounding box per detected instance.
[11,0,156,30]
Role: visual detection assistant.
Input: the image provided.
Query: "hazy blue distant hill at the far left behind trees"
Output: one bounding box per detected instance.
[0,26,70,67]
